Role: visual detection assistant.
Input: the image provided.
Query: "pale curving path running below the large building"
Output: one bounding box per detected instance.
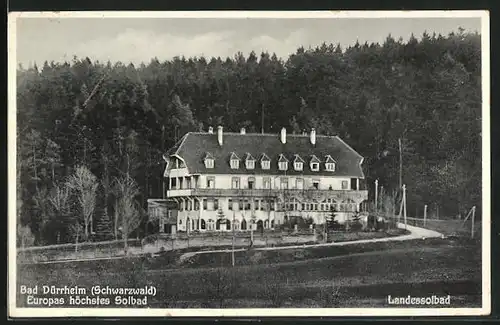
[178,223,444,264]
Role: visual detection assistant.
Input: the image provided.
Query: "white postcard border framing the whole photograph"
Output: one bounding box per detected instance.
[7,10,491,318]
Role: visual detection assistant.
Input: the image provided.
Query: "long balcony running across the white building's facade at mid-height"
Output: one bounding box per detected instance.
[167,188,368,201]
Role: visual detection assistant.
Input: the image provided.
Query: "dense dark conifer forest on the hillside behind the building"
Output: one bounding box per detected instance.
[17,29,481,245]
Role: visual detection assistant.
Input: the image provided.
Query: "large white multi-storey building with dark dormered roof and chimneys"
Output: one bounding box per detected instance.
[149,126,368,232]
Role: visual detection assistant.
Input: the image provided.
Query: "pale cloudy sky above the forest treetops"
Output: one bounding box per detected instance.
[16,17,481,67]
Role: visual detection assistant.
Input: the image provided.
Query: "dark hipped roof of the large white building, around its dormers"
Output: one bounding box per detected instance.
[167,132,364,178]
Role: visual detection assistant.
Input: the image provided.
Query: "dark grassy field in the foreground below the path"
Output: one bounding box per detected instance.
[18,235,481,308]
